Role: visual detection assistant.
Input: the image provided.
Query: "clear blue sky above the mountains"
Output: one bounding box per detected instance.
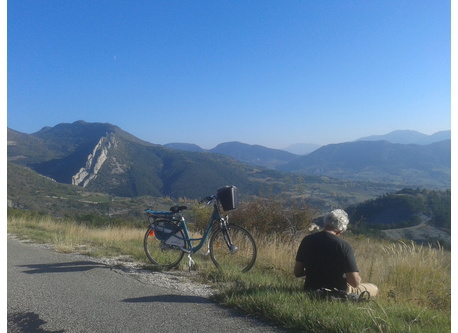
[7,0,451,148]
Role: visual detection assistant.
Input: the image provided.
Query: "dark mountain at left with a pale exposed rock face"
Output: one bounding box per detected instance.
[7,121,290,198]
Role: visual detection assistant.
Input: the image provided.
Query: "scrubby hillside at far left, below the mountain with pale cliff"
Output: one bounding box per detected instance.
[7,162,178,221]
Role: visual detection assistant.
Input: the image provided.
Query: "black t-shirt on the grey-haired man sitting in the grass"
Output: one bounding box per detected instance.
[296,231,359,290]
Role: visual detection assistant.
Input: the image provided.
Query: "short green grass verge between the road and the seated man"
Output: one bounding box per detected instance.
[206,276,451,332]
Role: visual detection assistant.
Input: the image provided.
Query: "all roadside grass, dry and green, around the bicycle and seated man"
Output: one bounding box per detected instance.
[8,215,451,333]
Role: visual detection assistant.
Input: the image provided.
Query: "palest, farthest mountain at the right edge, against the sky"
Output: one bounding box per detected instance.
[357,130,451,145]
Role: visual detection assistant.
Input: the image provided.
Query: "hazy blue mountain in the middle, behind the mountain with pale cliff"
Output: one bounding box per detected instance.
[209,141,298,169]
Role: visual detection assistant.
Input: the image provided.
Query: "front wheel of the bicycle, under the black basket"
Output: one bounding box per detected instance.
[210,225,257,272]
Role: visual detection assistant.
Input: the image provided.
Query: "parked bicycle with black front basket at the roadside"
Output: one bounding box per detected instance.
[143,186,257,272]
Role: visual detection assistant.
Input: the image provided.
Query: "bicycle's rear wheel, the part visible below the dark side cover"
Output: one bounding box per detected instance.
[143,227,184,269]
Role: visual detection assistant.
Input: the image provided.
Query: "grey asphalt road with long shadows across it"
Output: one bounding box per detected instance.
[7,237,282,333]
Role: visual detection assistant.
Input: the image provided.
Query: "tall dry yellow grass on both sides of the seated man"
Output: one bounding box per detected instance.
[255,231,451,309]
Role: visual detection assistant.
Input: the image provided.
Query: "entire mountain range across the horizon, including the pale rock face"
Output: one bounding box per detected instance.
[8,121,451,197]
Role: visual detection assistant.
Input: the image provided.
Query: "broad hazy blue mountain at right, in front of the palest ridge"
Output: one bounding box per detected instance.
[279,140,451,189]
